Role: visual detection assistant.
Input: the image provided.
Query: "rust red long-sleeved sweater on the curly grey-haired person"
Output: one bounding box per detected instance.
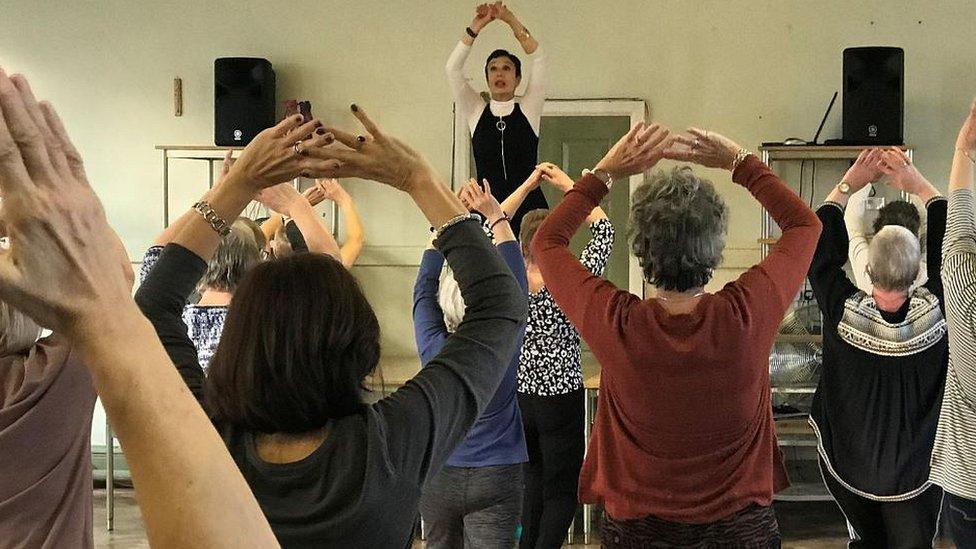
[532,156,820,523]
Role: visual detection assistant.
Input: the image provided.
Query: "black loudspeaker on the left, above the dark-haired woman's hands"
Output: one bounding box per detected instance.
[214,57,275,146]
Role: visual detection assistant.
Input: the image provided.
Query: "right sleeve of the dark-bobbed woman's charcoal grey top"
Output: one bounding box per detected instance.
[374,221,528,484]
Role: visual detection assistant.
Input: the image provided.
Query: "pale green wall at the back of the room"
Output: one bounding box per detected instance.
[0,0,976,355]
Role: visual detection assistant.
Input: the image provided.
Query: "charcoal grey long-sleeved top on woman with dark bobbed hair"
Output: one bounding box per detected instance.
[136,221,527,547]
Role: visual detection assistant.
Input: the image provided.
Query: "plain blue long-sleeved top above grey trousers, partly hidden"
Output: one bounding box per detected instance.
[413,240,529,467]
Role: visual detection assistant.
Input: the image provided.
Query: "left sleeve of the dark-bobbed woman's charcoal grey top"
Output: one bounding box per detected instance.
[135,244,207,404]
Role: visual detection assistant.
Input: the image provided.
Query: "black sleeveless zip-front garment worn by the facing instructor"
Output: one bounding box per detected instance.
[471,103,549,238]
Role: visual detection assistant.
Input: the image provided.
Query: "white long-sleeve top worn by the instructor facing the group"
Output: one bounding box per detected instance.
[445,41,548,135]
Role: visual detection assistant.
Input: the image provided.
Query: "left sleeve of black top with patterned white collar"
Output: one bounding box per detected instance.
[808,202,857,324]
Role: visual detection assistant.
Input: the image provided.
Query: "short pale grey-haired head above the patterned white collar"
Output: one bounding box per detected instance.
[868,225,921,292]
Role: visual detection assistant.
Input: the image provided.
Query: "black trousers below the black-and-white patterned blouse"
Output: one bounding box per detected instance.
[518,389,586,549]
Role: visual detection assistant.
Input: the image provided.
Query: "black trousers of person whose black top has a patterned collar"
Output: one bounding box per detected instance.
[820,460,942,549]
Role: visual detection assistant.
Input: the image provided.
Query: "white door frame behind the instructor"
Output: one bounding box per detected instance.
[451,99,647,297]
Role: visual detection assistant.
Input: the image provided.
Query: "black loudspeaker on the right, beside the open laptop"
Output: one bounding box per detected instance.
[844,47,905,145]
